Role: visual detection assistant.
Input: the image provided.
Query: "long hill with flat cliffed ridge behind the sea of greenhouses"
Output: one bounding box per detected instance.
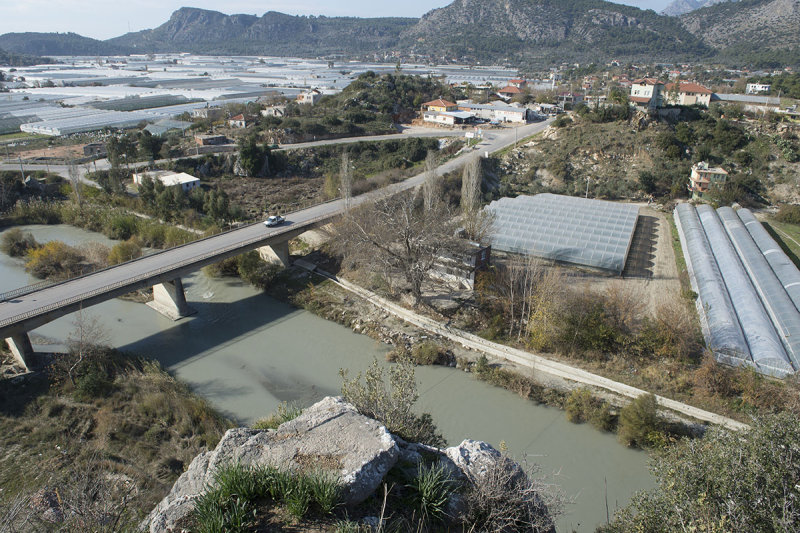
[108,7,417,57]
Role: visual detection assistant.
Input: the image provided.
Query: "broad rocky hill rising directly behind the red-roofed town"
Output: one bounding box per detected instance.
[403,0,709,63]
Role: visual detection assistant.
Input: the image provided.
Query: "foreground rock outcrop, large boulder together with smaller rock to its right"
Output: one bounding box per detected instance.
[141,397,552,533]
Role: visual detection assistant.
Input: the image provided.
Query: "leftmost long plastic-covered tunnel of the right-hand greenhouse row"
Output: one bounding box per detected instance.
[675,204,751,365]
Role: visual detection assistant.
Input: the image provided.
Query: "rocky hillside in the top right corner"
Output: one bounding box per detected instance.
[680,0,800,66]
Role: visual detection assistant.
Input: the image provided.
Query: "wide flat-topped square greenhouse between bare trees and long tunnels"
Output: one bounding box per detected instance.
[487,193,639,273]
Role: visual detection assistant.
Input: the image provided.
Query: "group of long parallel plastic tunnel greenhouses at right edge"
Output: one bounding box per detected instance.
[675,204,800,376]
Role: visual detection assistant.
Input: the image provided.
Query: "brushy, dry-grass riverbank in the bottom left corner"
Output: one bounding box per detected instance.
[0,347,232,531]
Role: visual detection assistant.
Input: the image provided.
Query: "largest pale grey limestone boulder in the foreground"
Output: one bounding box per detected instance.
[142,397,400,533]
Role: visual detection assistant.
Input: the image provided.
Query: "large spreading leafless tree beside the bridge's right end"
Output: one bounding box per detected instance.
[337,187,457,305]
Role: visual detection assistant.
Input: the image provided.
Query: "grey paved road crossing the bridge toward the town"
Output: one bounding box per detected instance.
[0,121,549,337]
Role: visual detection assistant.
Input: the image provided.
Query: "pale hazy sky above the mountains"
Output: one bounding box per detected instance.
[0,0,669,39]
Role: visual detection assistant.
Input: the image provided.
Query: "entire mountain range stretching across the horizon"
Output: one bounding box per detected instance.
[0,0,800,67]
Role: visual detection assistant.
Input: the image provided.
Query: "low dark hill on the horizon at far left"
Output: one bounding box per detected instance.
[0,32,130,56]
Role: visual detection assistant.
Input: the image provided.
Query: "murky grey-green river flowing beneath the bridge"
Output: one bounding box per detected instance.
[0,226,653,532]
